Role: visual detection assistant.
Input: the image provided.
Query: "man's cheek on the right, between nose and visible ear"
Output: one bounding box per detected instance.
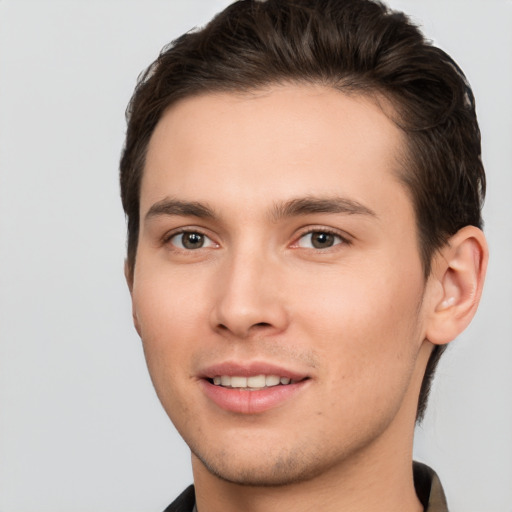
[297,264,423,392]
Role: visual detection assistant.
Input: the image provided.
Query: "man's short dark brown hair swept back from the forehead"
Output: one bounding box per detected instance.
[120,0,485,418]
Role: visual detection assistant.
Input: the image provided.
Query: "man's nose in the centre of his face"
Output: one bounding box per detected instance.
[211,250,289,339]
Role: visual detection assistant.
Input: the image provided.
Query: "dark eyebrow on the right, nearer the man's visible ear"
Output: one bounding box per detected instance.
[272,197,377,220]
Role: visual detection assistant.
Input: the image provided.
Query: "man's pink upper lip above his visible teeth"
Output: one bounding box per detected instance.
[199,361,309,381]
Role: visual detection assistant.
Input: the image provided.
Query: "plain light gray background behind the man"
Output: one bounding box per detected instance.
[0,0,512,512]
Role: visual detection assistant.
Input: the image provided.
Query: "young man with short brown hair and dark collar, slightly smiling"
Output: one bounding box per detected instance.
[121,0,487,512]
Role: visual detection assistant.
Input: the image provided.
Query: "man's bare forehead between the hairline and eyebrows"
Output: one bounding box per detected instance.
[141,85,405,218]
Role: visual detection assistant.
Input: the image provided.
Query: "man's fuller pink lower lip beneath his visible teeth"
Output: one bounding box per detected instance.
[200,379,308,414]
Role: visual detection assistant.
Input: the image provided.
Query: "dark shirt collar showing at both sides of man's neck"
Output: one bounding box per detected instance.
[164,462,448,512]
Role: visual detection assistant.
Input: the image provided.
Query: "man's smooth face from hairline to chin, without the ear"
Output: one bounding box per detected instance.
[131,85,432,485]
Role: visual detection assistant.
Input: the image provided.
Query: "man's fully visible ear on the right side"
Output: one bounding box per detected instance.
[426,226,489,345]
